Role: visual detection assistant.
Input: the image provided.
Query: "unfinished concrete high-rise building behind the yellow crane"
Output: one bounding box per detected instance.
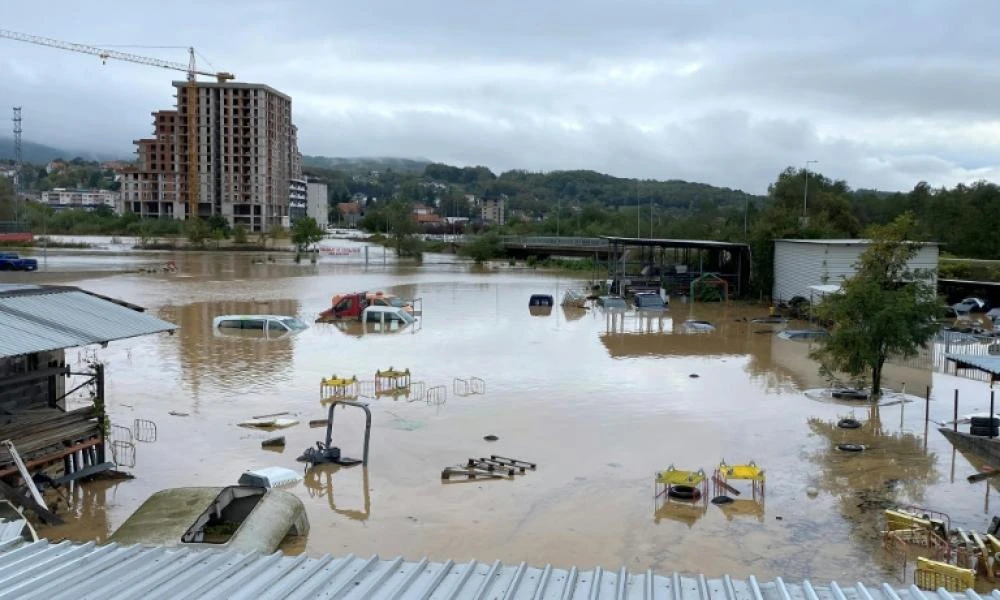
[122,81,301,232]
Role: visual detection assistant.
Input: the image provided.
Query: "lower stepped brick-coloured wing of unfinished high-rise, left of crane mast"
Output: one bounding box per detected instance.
[121,110,185,218]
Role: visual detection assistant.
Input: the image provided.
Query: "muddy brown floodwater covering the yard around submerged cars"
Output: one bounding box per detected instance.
[12,242,997,582]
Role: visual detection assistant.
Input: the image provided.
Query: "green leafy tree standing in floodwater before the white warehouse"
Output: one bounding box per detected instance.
[813,213,943,400]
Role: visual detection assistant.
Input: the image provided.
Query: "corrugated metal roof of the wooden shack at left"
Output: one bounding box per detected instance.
[0,286,177,356]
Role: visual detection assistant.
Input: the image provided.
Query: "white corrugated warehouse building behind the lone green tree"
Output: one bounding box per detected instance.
[771,240,938,302]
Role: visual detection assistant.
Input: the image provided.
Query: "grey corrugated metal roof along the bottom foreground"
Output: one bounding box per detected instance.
[0,541,988,600]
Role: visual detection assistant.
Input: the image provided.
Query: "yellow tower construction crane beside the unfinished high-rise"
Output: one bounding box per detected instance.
[0,29,236,218]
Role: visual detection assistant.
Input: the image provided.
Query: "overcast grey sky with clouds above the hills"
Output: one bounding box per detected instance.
[0,0,1000,192]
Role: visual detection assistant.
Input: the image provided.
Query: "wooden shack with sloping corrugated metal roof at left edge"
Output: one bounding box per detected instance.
[0,284,177,489]
